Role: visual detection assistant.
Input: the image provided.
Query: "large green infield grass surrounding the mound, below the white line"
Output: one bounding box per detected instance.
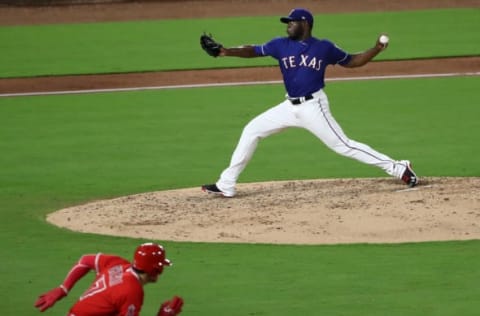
[0,77,480,316]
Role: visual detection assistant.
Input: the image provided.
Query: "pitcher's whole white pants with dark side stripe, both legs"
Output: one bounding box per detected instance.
[216,90,408,196]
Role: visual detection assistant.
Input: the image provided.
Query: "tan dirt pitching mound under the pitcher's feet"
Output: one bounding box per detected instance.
[47,178,480,244]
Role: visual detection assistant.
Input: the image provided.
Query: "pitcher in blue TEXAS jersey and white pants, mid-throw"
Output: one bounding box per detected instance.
[200,8,418,197]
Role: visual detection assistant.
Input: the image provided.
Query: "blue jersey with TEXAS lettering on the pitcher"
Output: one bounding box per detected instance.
[254,37,351,98]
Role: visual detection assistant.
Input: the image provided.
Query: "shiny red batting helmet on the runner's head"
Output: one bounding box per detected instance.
[132,243,171,275]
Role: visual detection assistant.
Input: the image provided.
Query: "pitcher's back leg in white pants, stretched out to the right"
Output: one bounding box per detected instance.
[304,95,408,178]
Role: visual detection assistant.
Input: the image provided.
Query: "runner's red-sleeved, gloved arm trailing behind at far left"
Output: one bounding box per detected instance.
[35,255,98,312]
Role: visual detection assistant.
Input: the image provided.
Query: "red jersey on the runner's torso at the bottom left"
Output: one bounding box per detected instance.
[69,253,144,316]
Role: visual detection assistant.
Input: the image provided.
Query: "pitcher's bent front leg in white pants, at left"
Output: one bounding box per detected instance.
[216,102,291,196]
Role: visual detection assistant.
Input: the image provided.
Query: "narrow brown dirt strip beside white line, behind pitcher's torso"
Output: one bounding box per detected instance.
[0,57,480,95]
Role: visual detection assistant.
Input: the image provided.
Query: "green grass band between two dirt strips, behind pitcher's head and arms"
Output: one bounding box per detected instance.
[0,9,480,77]
